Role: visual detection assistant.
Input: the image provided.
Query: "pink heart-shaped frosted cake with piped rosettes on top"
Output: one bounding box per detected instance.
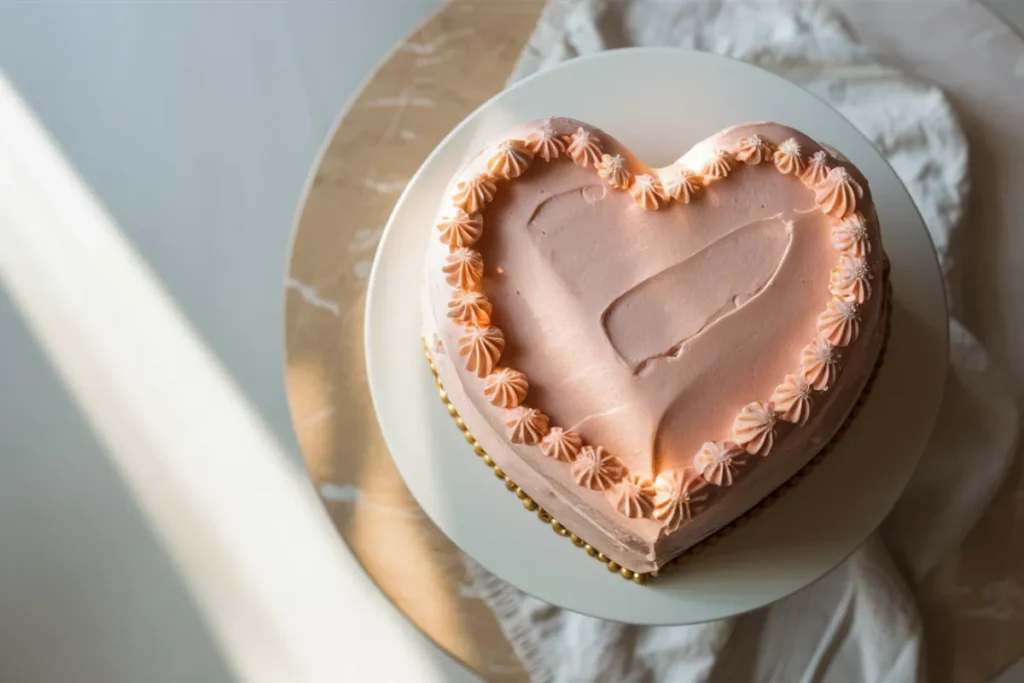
[423,118,888,578]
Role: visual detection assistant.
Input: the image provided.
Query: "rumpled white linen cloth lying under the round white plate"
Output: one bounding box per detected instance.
[467,0,1017,683]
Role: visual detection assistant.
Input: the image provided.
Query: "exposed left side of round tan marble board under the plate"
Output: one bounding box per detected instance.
[285,0,542,681]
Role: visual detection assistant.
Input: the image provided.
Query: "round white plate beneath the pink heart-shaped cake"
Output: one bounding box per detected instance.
[366,48,947,625]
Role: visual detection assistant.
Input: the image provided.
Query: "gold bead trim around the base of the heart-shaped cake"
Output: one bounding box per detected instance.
[423,266,893,585]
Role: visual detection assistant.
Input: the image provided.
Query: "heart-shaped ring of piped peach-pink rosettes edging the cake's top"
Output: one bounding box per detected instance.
[436,126,874,532]
